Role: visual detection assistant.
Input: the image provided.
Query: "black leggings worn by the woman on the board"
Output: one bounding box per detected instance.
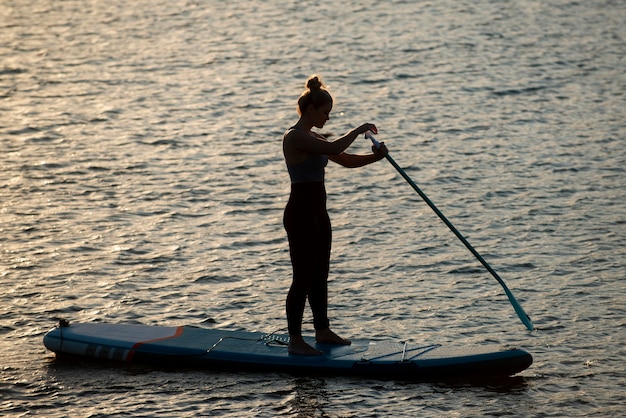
[283,181,332,336]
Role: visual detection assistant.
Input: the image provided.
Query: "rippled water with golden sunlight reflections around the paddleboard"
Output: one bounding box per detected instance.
[0,0,626,417]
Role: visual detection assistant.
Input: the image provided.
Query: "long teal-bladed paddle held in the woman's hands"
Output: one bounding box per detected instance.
[365,132,535,331]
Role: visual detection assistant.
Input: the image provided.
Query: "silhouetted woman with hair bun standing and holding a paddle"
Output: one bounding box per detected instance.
[283,75,387,355]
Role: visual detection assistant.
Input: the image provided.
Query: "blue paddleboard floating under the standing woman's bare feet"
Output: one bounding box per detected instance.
[43,321,532,381]
